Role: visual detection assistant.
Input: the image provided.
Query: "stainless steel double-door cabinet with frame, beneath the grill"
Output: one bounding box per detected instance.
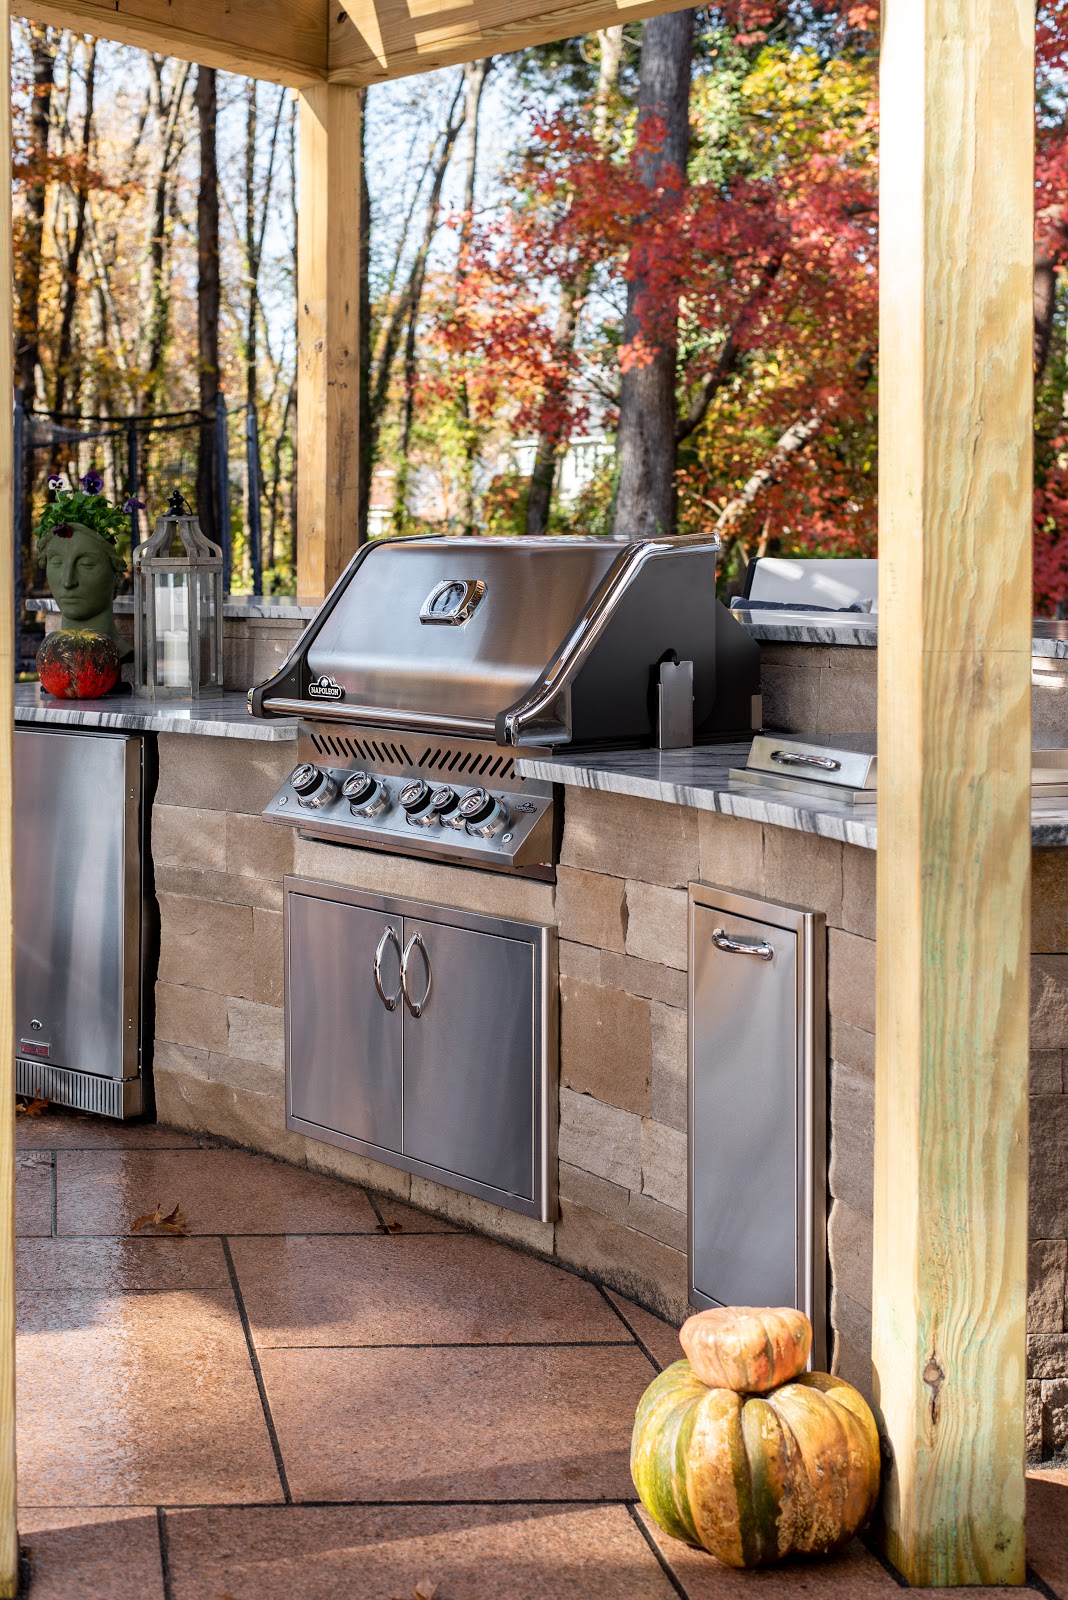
[285,878,556,1219]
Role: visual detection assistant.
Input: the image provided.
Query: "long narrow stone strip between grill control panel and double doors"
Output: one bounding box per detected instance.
[293,838,559,923]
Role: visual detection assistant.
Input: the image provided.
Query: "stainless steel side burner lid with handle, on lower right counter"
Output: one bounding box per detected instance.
[731,733,1068,806]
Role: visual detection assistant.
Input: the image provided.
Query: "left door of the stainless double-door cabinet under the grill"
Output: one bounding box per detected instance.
[286,893,403,1150]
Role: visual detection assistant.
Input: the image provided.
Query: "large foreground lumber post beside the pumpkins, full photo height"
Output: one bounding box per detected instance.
[873,0,1034,1586]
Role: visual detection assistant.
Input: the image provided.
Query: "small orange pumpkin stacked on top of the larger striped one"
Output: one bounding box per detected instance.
[678,1306,812,1395]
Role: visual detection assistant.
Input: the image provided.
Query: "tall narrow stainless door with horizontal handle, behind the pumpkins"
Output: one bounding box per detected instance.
[689,883,827,1360]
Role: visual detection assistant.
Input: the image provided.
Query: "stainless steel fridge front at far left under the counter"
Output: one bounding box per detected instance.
[14,728,141,1088]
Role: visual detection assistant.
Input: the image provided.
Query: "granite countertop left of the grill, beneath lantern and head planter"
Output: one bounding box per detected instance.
[14,683,299,741]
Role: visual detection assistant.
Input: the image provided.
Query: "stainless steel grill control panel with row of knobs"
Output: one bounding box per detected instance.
[264,762,553,875]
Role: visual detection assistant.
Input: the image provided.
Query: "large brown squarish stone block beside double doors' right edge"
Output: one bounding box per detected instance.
[560,978,652,1113]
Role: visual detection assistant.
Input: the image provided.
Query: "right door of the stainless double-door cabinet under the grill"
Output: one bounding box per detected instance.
[404,917,536,1202]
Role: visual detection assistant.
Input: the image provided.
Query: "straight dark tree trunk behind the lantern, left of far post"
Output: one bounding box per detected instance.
[193,67,221,542]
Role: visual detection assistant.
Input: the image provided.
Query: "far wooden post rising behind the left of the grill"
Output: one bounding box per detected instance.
[297,83,361,602]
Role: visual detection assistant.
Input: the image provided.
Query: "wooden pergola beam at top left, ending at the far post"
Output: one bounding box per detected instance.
[14,0,329,88]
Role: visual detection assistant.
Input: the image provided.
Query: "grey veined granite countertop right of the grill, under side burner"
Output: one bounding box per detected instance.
[515,741,1068,850]
